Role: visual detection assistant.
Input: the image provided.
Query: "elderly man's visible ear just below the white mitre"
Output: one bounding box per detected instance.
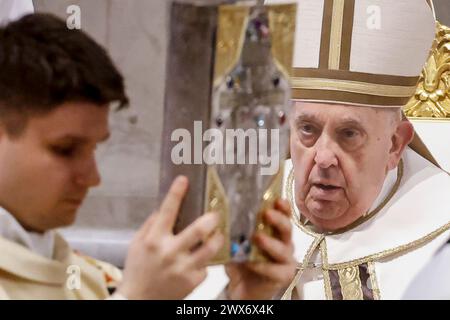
[388,120,414,170]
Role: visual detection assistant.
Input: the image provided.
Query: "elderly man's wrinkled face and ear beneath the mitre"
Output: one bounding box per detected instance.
[291,102,413,230]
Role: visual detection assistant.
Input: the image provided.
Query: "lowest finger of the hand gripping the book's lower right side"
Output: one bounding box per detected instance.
[246,263,295,286]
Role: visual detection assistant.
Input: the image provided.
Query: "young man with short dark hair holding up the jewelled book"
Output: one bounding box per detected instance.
[0,14,295,299]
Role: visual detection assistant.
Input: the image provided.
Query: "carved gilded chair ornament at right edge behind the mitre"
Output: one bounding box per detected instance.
[404,22,450,119]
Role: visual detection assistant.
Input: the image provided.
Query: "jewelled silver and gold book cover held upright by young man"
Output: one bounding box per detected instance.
[160,1,296,263]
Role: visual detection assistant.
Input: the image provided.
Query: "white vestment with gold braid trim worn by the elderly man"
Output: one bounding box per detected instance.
[286,149,450,299]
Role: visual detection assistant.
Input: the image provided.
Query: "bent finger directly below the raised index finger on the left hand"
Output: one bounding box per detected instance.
[175,213,219,251]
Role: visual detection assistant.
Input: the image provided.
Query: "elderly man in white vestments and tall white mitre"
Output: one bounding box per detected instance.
[192,0,450,300]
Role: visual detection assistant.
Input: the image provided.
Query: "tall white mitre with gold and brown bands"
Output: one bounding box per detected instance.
[266,0,437,164]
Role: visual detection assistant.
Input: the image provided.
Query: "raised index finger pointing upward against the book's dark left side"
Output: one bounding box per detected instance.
[154,176,189,232]
